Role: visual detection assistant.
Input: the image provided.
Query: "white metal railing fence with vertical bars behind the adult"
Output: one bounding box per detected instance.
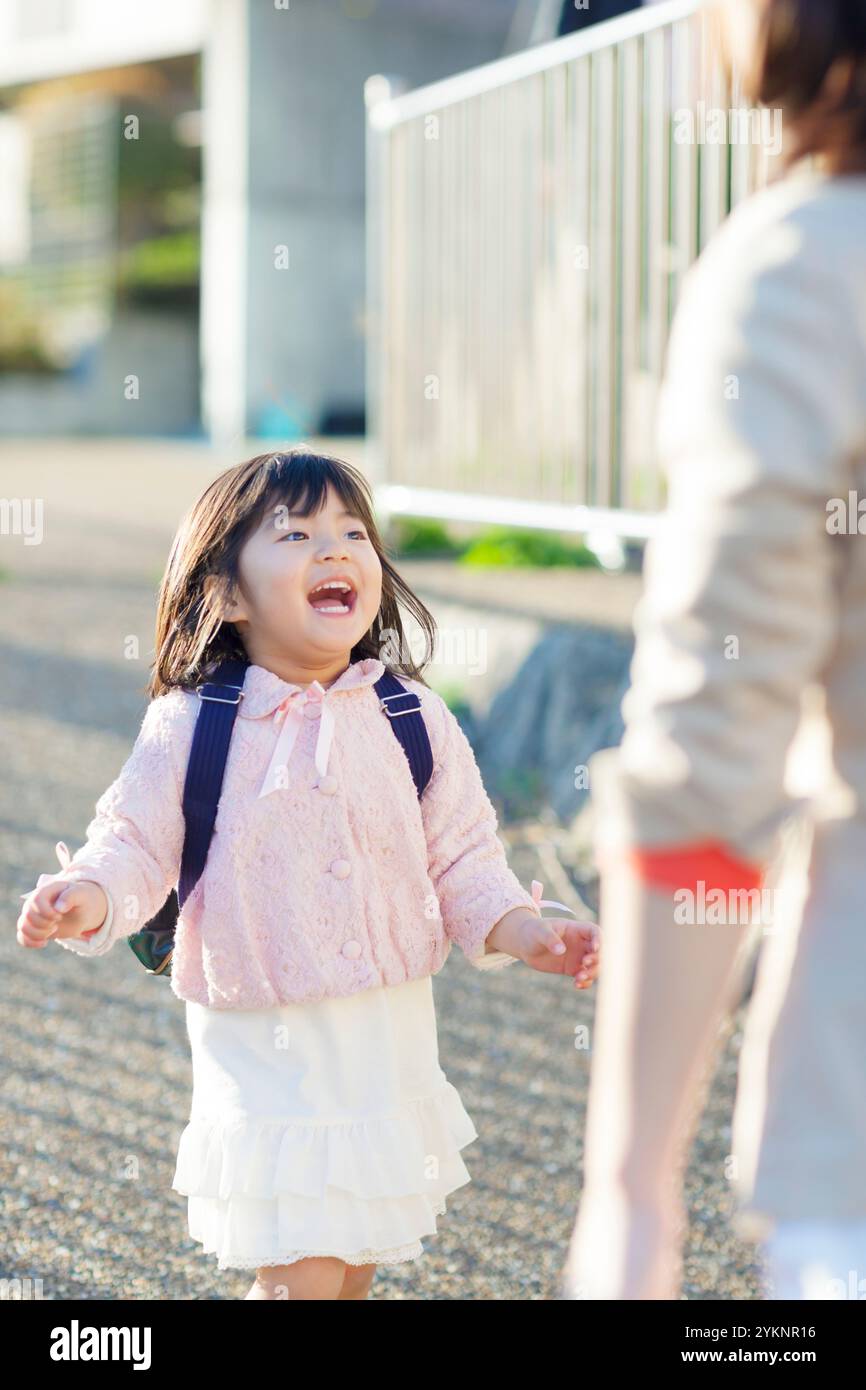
[366,0,777,543]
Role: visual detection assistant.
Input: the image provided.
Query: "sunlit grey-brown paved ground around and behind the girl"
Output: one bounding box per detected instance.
[0,441,759,1300]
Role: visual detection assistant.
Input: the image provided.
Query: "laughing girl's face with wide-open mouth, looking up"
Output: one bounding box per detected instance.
[224,487,382,684]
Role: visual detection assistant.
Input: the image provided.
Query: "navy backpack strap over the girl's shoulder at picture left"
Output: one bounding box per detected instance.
[178,659,249,908]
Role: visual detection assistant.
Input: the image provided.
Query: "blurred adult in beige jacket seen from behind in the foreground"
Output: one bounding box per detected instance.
[563,0,866,1298]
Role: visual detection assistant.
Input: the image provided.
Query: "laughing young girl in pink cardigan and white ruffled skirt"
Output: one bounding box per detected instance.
[18,448,598,1300]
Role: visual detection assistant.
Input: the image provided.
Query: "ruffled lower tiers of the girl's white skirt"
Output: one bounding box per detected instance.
[171,1081,478,1269]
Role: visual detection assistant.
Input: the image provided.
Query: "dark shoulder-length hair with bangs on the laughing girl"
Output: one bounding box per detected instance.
[146,445,436,699]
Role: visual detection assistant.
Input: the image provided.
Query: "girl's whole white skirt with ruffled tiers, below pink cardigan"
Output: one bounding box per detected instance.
[171,976,478,1269]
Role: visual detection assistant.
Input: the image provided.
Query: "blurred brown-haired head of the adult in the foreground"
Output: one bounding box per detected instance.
[745,0,866,167]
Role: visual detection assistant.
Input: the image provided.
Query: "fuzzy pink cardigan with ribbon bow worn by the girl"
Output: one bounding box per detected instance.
[38,657,542,1009]
